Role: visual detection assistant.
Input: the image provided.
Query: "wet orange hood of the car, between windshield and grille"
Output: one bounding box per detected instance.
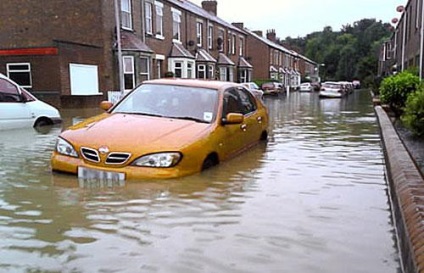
[61,113,212,152]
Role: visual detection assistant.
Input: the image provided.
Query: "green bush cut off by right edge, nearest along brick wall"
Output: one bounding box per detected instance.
[401,85,424,136]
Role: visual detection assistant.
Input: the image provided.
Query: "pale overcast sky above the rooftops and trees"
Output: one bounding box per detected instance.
[190,0,408,39]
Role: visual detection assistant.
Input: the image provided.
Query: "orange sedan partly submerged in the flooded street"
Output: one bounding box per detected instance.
[51,79,268,180]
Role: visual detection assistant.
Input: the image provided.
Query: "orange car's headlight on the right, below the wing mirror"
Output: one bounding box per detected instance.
[132,152,182,168]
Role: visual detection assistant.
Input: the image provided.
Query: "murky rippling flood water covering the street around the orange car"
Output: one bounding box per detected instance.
[0,91,401,273]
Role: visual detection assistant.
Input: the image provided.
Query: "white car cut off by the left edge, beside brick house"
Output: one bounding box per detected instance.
[0,73,62,131]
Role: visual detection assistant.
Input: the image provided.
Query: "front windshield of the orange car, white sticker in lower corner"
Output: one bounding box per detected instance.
[112,84,218,123]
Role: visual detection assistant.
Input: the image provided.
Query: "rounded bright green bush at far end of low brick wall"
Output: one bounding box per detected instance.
[379,71,420,116]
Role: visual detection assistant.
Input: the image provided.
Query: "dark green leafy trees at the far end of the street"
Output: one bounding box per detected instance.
[282,19,391,85]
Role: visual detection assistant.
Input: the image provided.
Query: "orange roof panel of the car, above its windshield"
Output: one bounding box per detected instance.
[143,78,240,89]
